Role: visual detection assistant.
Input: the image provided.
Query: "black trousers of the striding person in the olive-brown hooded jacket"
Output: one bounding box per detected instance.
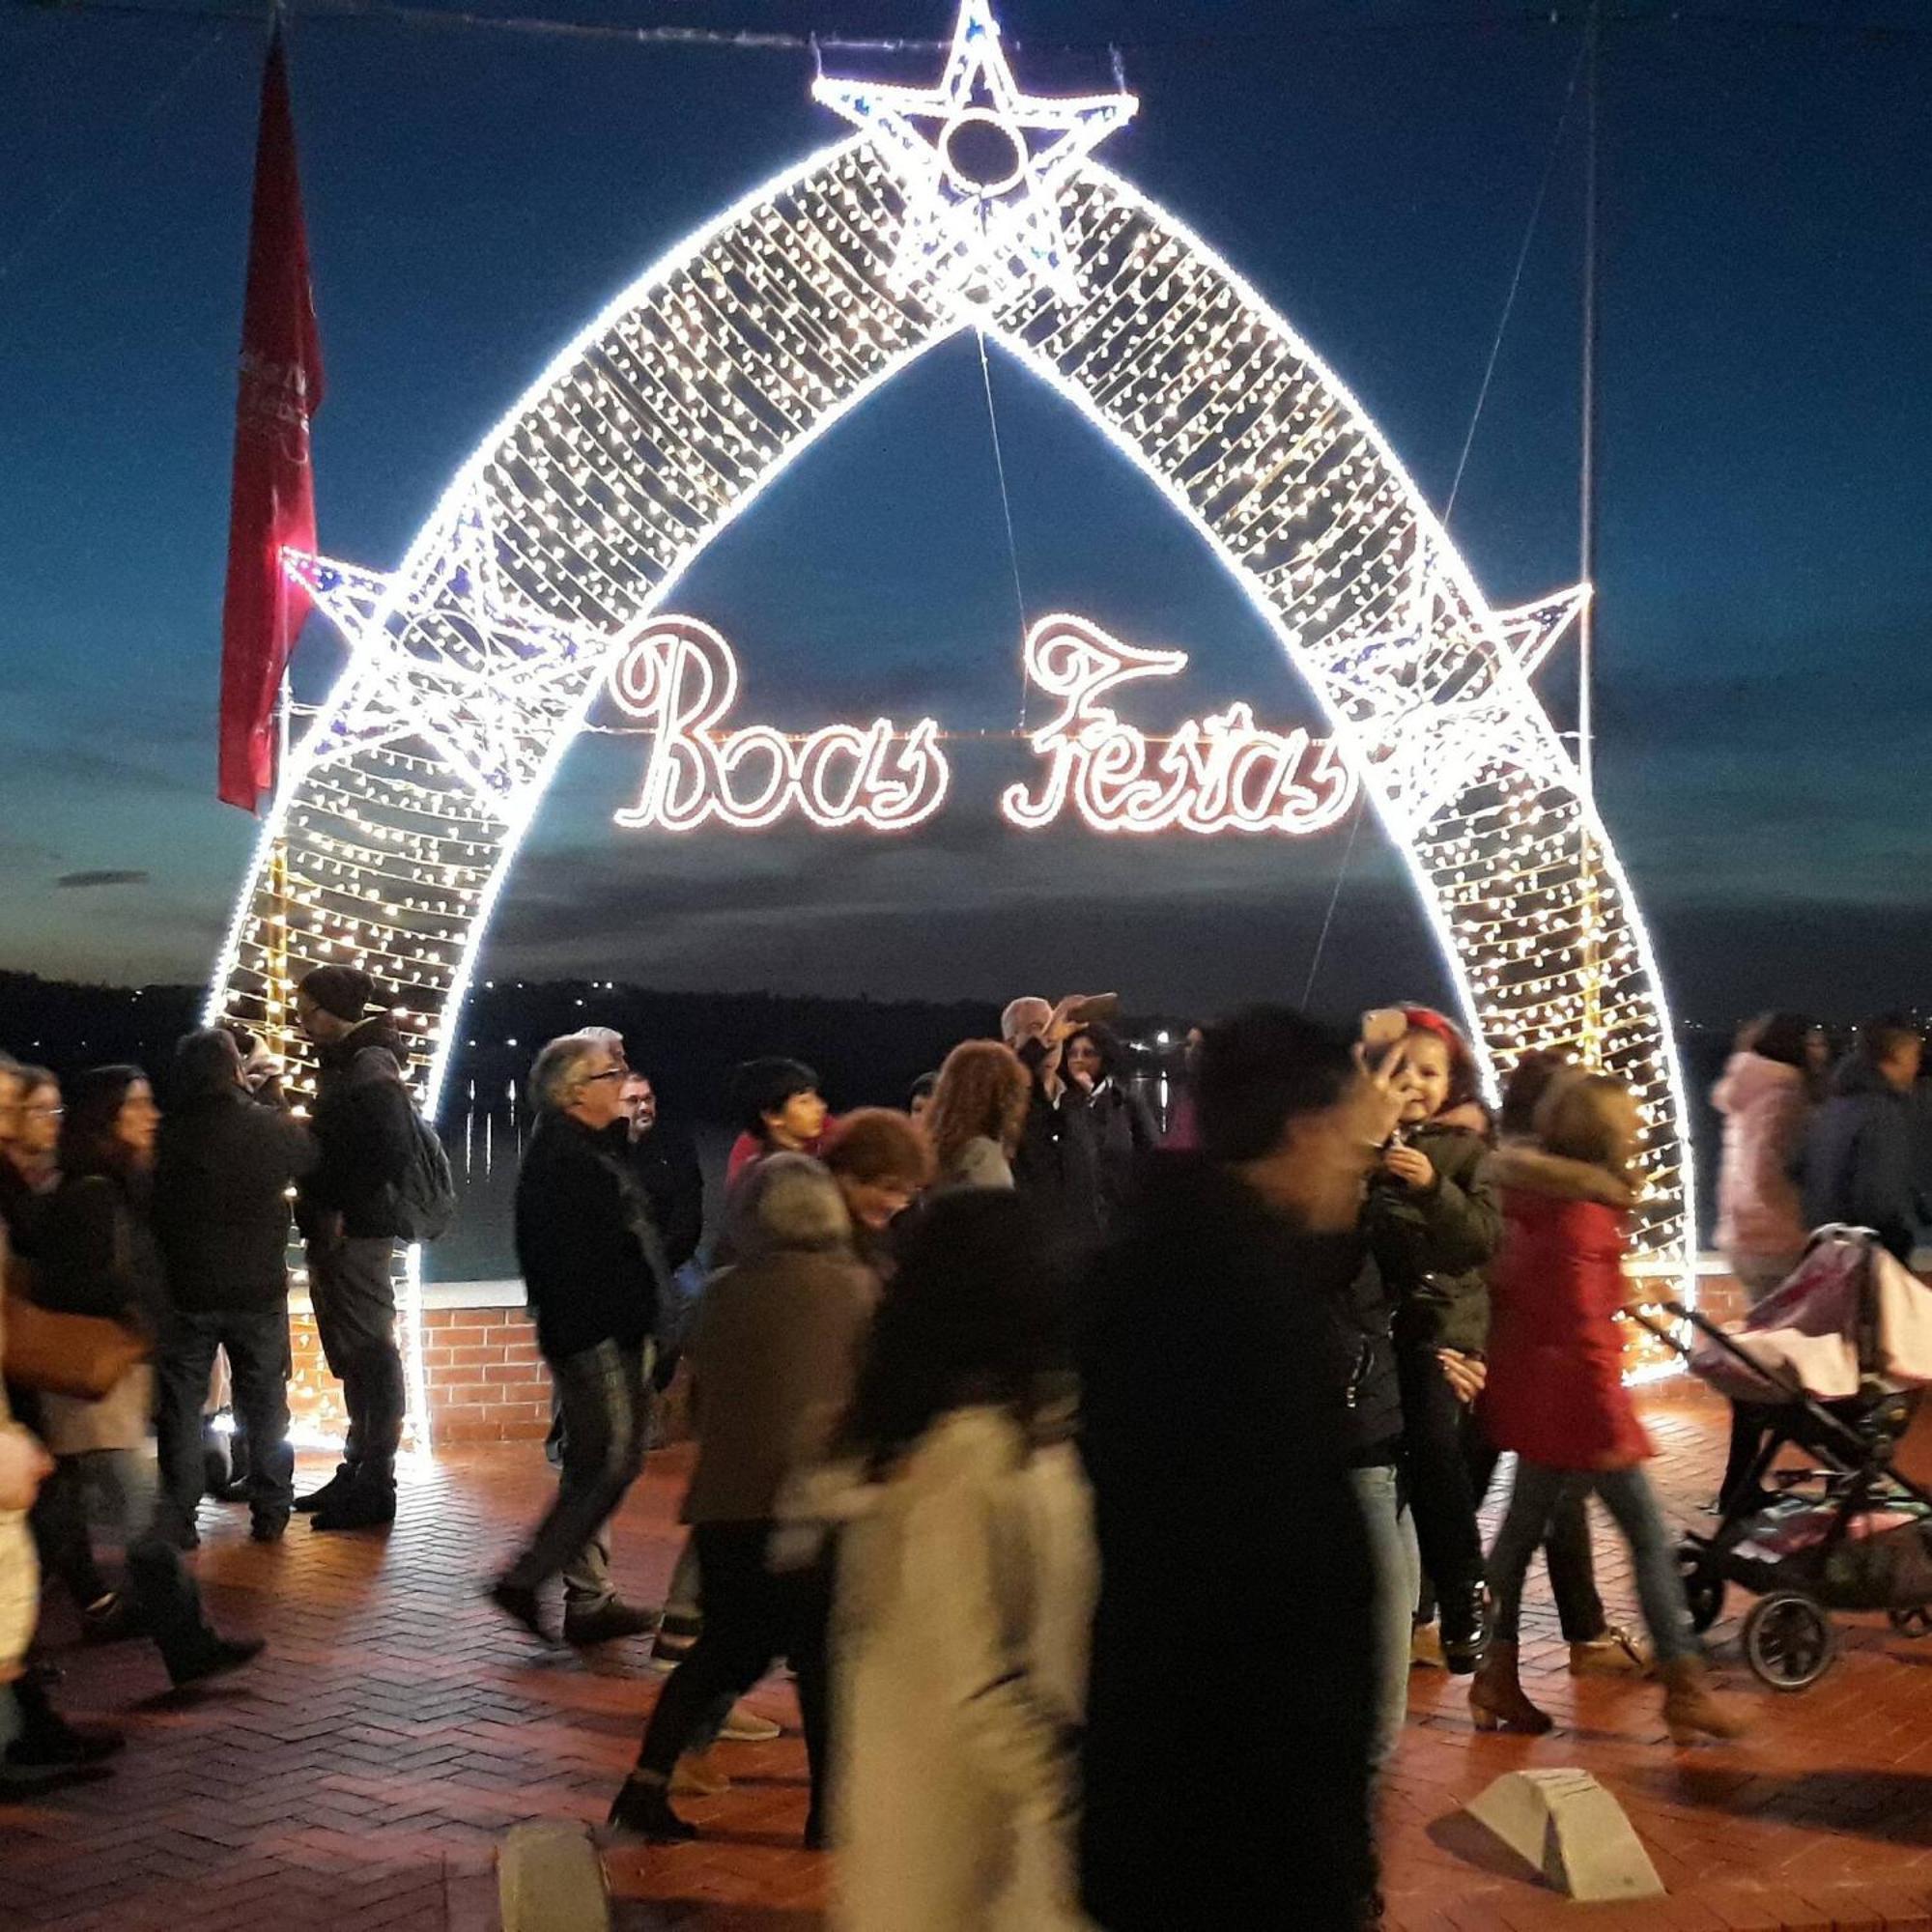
[638,1522,831,1828]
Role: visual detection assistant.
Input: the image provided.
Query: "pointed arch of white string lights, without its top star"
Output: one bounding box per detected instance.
[211,139,1694,1337]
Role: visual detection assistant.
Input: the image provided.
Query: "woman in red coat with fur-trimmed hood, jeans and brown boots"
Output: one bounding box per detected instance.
[1468,1074,1743,1745]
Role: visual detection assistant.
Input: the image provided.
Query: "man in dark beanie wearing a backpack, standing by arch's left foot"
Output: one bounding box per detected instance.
[296,966,415,1530]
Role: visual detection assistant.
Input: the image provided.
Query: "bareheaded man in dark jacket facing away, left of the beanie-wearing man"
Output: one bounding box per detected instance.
[155,1028,317,1544]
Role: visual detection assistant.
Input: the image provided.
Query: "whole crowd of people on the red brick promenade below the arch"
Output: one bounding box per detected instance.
[0,966,1924,1932]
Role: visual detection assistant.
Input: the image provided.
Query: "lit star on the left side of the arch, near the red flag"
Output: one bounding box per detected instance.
[282,491,609,819]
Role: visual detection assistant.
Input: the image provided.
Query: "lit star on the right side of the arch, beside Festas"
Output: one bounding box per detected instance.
[1314,543,1590,833]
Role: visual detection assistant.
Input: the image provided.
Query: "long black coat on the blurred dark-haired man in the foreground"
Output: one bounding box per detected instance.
[1080,1153,1393,1932]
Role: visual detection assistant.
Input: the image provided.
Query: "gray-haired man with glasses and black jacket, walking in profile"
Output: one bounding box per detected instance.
[489,1034,668,1644]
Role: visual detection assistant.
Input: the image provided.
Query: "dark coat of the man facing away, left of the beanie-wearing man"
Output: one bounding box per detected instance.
[155,1086,319,1314]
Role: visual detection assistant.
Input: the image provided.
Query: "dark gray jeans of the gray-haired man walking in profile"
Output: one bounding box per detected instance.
[502,1341,651,1611]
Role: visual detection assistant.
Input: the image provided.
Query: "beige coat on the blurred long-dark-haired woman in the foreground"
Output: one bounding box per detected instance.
[831,1408,1097,1932]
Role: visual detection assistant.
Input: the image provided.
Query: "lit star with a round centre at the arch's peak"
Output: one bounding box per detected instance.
[811,0,1140,303]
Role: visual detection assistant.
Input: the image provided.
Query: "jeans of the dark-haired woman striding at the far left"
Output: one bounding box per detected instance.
[33,1453,214,1669]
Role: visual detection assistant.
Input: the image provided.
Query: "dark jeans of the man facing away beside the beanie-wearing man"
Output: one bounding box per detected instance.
[155,1302,296,1528]
